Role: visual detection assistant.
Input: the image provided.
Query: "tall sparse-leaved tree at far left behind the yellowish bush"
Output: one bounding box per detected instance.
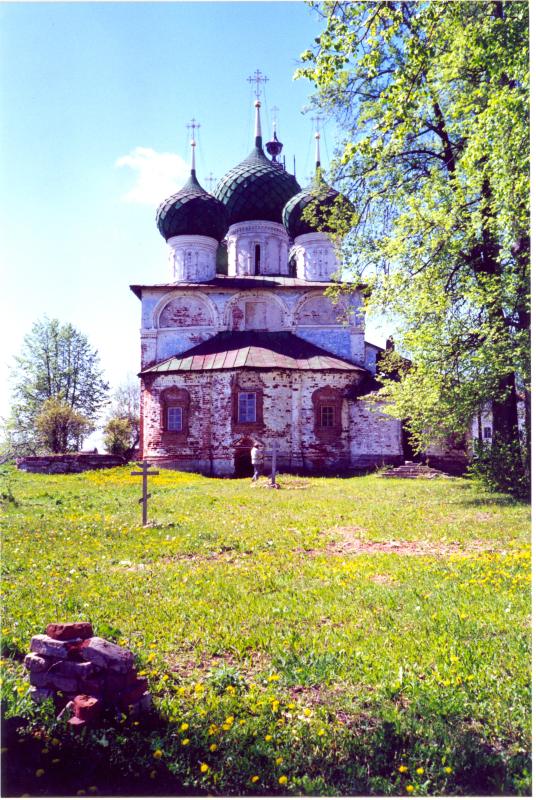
[7,318,108,455]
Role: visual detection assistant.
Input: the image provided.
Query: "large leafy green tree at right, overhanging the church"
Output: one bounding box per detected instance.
[299,0,530,494]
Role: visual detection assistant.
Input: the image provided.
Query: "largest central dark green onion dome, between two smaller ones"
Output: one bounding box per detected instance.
[214,142,300,225]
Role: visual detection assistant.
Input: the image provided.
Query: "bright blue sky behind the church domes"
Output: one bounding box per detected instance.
[0,2,383,444]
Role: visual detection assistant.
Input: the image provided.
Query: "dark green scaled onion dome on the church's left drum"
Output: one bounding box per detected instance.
[156,170,229,242]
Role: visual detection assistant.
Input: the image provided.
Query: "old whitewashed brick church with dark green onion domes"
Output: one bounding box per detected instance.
[131,98,403,477]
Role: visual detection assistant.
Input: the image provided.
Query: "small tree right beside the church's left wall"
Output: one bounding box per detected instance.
[104,375,140,458]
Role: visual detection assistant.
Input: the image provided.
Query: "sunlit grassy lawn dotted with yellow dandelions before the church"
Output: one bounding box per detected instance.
[0,467,531,796]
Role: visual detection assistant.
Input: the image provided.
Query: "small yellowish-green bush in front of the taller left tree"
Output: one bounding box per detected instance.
[35,397,92,453]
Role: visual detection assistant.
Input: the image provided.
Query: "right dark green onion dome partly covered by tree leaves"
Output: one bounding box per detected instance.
[283,177,353,239]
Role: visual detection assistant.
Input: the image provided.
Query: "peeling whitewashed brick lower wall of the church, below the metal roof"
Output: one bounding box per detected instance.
[142,370,401,476]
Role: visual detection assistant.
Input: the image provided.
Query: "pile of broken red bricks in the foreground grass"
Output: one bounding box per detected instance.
[24,622,151,727]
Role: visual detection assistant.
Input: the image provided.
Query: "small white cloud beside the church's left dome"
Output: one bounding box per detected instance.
[115,147,190,206]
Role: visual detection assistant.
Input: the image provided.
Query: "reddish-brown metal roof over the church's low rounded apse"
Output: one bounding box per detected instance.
[140,331,367,375]
